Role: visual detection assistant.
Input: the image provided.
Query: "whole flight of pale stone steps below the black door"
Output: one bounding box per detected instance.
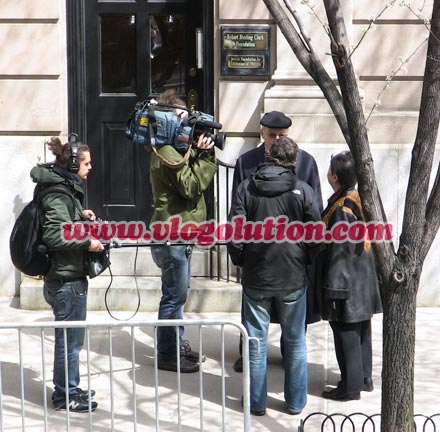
[20,247,241,312]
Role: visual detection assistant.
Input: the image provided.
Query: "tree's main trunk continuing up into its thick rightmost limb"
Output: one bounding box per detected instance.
[382,4,440,432]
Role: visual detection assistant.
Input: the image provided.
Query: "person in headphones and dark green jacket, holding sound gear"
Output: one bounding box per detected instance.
[31,137,104,412]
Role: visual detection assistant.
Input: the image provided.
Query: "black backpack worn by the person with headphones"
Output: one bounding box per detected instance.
[9,184,74,276]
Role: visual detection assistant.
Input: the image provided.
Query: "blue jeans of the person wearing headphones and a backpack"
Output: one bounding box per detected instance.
[44,278,88,405]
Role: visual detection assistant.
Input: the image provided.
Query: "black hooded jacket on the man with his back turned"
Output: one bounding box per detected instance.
[228,164,321,291]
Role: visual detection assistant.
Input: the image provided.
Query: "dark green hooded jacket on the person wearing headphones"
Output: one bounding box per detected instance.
[31,165,90,280]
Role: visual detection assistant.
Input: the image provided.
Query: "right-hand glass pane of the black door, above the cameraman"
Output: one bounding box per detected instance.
[150,15,186,94]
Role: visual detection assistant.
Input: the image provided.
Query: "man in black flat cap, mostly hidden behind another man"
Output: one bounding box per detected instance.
[231,111,323,372]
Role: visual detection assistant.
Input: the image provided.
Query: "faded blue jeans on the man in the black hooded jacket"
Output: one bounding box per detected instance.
[243,288,307,411]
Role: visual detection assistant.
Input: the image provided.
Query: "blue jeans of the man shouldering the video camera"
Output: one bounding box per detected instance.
[151,245,192,361]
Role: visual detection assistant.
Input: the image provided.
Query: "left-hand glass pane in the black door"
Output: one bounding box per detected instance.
[101,14,136,93]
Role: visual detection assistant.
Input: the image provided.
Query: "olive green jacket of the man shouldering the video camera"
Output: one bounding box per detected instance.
[150,145,217,223]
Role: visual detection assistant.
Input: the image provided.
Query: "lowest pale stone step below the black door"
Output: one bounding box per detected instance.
[20,275,241,319]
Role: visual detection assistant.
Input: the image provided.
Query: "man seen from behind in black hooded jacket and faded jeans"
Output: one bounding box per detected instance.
[228,137,321,415]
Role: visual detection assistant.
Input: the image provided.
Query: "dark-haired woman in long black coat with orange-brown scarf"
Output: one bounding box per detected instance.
[317,151,382,401]
